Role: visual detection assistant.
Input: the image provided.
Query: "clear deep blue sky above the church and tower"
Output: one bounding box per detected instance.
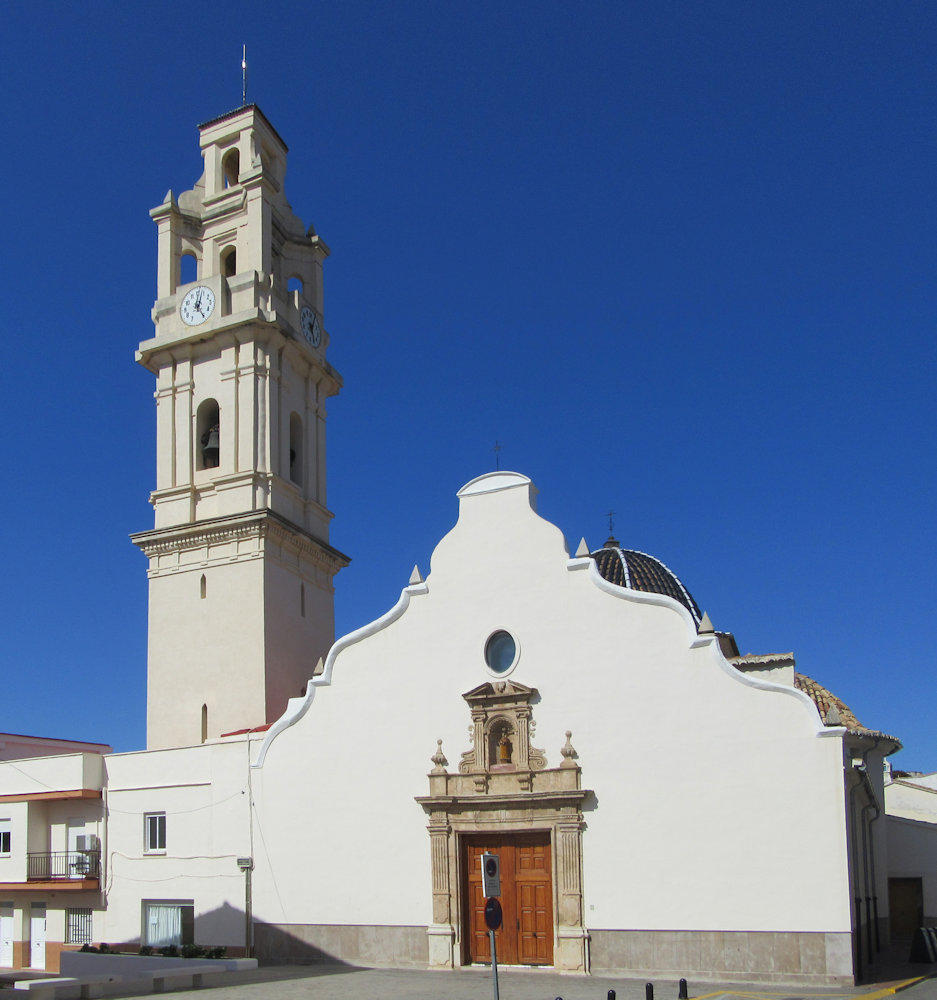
[0,0,937,770]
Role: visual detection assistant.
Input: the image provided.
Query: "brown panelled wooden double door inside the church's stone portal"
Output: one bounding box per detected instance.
[462,831,553,965]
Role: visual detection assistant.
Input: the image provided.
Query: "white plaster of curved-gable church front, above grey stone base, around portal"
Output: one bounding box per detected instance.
[245,474,850,931]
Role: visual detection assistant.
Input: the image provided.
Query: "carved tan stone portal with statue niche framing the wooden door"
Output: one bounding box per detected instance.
[417,680,590,972]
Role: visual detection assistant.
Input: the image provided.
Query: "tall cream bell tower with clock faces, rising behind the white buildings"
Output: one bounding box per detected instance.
[133,104,348,749]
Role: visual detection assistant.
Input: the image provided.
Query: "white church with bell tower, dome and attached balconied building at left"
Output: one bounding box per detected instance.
[0,105,920,984]
